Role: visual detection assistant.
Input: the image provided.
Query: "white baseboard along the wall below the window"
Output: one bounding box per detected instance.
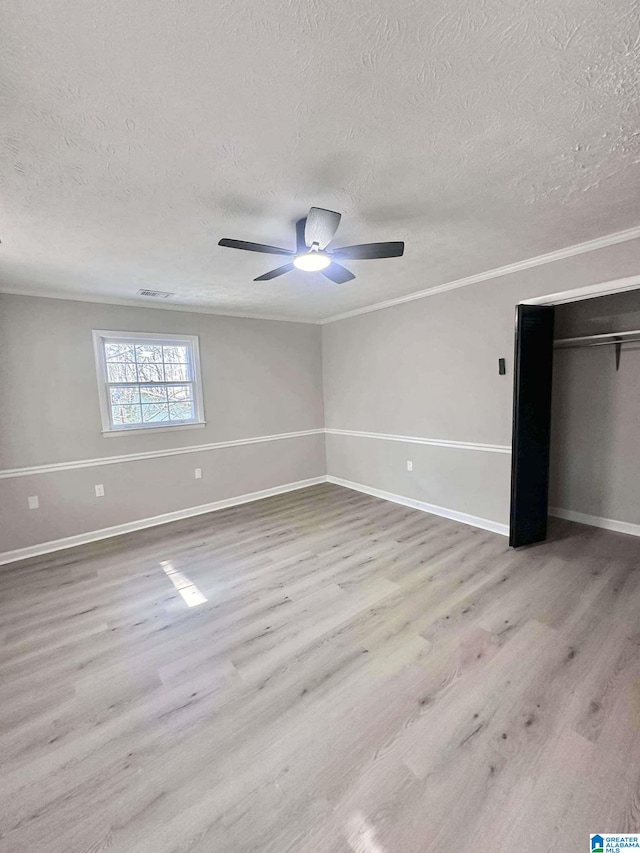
[0,475,327,566]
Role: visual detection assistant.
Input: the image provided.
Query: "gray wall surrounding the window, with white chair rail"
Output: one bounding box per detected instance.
[0,295,325,552]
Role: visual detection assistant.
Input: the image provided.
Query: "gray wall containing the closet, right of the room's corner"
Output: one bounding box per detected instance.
[323,233,640,525]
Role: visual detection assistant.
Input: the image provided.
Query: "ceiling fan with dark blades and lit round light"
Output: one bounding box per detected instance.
[218,207,404,284]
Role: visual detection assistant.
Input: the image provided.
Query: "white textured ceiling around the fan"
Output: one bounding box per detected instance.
[0,0,640,318]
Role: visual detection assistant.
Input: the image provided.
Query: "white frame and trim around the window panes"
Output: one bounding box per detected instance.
[92,329,206,438]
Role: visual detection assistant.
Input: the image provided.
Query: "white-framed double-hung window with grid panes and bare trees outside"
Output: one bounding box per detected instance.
[93,331,204,435]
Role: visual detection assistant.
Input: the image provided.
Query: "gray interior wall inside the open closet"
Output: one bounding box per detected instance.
[550,291,640,524]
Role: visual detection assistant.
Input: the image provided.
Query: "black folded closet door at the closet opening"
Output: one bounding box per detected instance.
[509,305,554,548]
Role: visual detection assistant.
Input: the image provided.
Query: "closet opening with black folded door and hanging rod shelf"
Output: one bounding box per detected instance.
[509,283,640,547]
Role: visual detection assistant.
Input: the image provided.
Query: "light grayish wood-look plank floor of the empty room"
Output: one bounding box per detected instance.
[0,485,640,853]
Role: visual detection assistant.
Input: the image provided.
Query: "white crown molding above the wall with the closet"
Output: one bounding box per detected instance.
[320,225,640,326]
